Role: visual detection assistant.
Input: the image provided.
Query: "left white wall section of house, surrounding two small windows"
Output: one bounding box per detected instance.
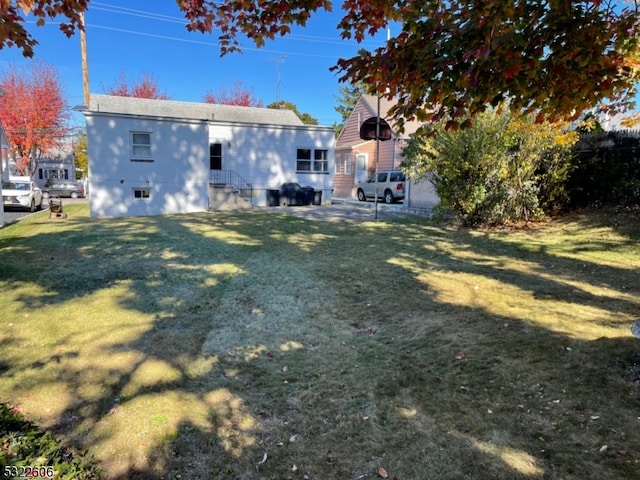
[86,112,209,217]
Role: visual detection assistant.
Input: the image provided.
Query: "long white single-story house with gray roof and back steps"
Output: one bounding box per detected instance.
[84,95,335,217]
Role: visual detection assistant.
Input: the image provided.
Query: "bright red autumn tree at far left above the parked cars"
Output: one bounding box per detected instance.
[0,61,69,175]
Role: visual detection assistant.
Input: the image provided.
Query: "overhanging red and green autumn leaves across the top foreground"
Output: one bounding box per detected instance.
[0,0,640,128]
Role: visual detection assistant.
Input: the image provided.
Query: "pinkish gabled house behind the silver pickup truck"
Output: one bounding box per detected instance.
[333,95,438,209]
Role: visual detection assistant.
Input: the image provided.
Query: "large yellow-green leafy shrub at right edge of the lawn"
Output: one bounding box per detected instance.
[402,109,577,226]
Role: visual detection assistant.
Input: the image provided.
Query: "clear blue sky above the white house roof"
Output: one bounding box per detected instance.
[0,0,386,126]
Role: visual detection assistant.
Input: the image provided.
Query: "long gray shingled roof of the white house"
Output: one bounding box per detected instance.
[85,94,304,126]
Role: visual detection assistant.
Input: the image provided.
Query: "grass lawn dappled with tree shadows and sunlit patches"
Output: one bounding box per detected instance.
[0,205,640,480]
